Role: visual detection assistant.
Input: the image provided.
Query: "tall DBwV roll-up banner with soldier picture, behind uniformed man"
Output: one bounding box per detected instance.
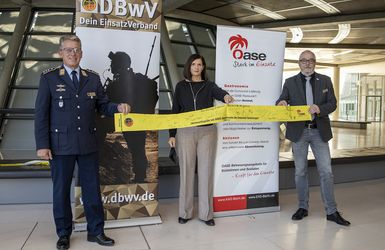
[75,0,162,230]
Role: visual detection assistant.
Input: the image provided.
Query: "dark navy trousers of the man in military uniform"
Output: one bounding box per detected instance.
[50,152,104,237]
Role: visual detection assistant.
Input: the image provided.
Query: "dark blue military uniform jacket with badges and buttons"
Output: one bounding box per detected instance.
[35,66,117,155]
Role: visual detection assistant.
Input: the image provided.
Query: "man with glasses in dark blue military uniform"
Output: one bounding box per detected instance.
[35,35,130,249]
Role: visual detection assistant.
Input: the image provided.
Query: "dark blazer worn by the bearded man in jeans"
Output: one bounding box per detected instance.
[276,73,337,142]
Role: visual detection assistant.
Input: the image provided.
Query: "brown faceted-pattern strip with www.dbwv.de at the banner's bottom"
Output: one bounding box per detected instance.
[75,183,158,223]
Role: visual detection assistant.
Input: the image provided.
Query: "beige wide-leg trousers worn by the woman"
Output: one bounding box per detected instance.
[176,125,217,221]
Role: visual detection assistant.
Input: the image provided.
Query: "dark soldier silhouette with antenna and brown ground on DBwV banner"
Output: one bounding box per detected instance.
[97,37,159,185]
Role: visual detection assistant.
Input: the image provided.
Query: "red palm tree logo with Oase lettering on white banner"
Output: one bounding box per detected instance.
[228,34,267,61]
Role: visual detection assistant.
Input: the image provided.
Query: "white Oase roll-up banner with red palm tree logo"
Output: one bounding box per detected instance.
[214,26,286,216]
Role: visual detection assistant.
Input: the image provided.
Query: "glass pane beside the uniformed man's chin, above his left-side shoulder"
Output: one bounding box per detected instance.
[15,61,61,87]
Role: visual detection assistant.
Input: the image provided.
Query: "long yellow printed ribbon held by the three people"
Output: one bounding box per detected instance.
[115,105,311,132]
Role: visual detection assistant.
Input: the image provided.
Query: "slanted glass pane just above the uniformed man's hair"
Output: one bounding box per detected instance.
[31,11,73,33]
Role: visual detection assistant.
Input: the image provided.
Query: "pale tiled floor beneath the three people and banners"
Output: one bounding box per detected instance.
[0,179,385,250]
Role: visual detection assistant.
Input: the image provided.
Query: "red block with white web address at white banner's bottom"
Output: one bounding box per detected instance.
[214,195,247,212]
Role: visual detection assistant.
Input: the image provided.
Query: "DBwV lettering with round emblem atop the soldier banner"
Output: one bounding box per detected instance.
[80,0,158,18]
